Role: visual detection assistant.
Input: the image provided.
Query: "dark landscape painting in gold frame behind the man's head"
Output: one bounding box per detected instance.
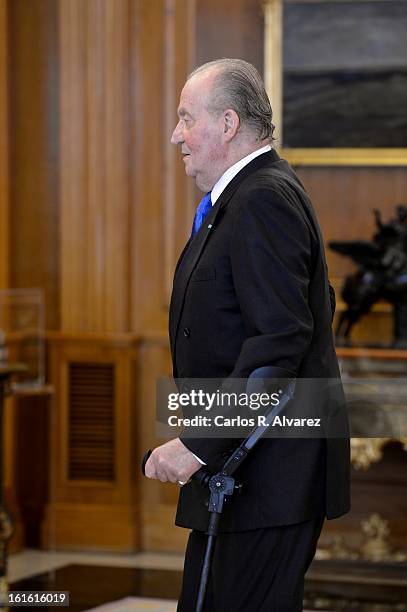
[264,0,407,165]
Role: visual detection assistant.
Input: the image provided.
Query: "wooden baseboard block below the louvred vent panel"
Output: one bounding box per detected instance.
[42,503,140,552]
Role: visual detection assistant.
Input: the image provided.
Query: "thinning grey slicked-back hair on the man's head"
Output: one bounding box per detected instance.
[188,58,274,142]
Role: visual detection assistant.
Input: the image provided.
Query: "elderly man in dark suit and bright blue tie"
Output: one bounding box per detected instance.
[146,59,349,612]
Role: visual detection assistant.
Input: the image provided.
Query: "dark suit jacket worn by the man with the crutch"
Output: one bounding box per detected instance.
[170,150,349,531]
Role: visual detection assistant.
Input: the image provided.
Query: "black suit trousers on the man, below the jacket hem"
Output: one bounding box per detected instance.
[177,518,324,612]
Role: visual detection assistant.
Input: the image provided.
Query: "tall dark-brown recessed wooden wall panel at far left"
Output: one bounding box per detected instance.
[7,0,59,329]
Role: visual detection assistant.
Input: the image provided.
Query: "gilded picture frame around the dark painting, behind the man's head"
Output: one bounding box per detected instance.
[263,0,407,166]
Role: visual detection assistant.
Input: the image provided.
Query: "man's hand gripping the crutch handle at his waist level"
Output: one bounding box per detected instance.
[145,438,202,483]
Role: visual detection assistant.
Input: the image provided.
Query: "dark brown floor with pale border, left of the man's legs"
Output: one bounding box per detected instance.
[8,550,183,612]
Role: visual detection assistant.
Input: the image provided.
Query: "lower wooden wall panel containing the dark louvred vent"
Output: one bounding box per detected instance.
[43,334,140,551]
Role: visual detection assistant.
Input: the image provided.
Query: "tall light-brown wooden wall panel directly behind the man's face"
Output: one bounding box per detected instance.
[131,0,195,336]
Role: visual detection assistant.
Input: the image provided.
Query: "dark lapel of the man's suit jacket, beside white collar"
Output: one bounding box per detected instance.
[169,149,280,360]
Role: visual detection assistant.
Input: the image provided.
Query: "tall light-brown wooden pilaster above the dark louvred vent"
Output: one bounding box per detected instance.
[59,0,132,332]
